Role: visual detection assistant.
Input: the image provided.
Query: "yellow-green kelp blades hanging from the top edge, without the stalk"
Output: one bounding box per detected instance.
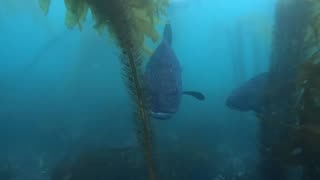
[39,0,169,44]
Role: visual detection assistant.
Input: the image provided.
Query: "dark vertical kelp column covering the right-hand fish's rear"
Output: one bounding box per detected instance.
[260,0,310,179]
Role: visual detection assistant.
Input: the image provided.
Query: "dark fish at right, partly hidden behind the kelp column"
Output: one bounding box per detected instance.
[225,72,294,113]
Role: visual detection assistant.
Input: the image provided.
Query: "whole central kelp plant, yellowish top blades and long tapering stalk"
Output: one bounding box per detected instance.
[39,0,169,180]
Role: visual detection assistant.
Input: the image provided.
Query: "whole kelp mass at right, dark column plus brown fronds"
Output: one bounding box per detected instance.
[252,0,320,179]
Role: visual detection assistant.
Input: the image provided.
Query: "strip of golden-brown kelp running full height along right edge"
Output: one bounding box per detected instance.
[296,0,320,180]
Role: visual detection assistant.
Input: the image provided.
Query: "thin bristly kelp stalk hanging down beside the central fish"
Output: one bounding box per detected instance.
[106,3,156,180]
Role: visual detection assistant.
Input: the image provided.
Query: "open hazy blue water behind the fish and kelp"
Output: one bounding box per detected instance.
[0,0,275,180]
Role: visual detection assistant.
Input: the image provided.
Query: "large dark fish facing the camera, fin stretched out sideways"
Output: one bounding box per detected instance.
[144,24,205,119]
